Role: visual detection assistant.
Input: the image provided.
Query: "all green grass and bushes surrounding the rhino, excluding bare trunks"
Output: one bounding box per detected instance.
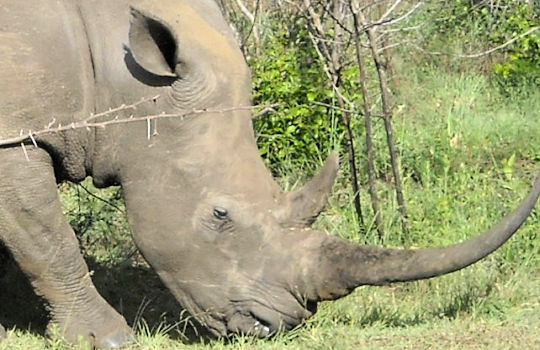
[0,0,540,349]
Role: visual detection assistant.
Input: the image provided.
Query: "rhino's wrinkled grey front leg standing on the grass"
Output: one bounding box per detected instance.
[0,146,133,348]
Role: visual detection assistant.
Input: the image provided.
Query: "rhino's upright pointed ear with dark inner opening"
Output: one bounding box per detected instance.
[129,7,178,77]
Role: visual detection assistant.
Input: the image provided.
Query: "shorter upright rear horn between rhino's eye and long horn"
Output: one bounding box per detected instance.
[276,152,339,227]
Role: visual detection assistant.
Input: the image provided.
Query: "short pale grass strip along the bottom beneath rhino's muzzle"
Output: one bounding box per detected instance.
[0,292,540,350]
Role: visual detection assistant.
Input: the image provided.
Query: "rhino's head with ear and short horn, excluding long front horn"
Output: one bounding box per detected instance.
[119,3,338,335]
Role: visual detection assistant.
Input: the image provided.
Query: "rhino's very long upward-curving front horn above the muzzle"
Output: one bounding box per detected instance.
[303,175,540,301]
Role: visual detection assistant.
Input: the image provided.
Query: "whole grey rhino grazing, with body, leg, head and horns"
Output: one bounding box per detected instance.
[0,0,540,348]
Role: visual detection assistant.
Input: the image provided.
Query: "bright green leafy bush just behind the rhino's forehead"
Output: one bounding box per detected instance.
[249,13,343,170]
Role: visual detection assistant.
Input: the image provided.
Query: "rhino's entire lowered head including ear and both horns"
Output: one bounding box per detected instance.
[87,0,540,337]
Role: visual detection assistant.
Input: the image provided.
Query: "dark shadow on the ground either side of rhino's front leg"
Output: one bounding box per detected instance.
[0,242,212,343]
